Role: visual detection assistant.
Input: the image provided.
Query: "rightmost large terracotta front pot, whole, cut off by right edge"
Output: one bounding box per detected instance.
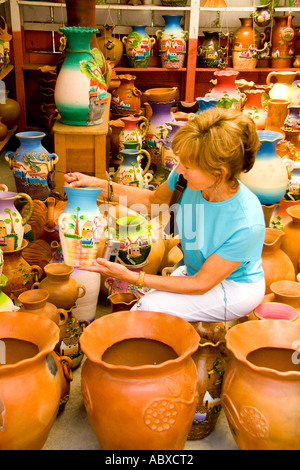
[222,320,300,450]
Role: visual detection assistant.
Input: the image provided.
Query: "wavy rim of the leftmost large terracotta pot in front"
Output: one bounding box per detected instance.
[0,312,60,377]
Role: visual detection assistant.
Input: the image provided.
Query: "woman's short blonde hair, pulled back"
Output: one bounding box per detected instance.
[172,108,260,184]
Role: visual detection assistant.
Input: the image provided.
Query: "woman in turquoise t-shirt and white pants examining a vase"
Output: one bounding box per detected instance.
[65,108,265,322]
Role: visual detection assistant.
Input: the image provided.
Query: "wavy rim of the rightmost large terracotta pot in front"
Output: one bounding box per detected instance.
[225,319,300,380]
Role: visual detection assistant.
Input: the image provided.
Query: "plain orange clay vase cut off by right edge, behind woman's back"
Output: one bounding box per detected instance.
[281,205,300,275]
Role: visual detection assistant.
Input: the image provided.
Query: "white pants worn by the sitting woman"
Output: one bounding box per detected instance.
[132,266,265,322]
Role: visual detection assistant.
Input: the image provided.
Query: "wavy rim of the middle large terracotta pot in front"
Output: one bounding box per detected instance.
[79,310,200,376]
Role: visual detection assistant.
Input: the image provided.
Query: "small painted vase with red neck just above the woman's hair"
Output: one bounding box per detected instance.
[207,70,245,110]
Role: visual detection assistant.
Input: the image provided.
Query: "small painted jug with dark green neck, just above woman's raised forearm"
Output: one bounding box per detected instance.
[111,149,153,187]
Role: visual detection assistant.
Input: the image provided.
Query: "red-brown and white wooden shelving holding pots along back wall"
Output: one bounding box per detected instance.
[7,0,300,130]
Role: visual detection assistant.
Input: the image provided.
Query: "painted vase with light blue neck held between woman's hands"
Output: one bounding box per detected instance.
[58,187,106,266]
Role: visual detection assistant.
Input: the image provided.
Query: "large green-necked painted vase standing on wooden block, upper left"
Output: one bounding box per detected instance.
[54,26,109,126]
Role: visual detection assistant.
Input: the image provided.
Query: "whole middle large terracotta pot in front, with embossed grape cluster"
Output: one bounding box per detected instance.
[80,311,199,450]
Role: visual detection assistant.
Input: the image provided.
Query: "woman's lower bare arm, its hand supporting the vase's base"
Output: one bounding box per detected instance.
[82,254,240,295]
